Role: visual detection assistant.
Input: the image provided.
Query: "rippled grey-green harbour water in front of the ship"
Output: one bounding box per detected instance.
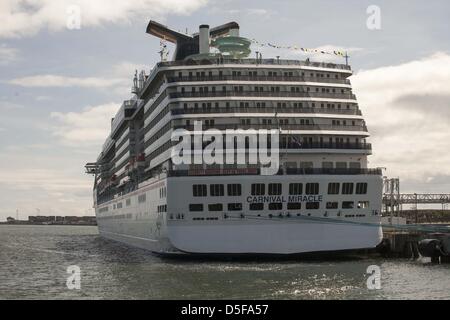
[0,225,450,299]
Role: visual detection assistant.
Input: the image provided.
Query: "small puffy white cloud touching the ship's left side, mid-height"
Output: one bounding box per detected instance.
[50,103,120,147]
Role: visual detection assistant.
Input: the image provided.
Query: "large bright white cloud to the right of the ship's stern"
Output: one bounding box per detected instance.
[351,53,450,188]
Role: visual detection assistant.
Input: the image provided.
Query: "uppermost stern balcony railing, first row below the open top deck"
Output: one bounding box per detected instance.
[167,75,350,85]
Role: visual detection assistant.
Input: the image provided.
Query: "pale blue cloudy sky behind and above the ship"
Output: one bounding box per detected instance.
[0,0,450,221]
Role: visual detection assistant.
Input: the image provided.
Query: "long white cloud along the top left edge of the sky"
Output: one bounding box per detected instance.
[0,0,207,38]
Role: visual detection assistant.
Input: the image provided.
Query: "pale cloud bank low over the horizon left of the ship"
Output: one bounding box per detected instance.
[0,143,97,220]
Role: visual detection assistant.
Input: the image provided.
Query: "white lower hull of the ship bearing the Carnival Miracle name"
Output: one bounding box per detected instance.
[96,175,382,255]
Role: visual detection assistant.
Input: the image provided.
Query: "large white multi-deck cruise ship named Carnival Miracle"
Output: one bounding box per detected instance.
[86,21,382,256]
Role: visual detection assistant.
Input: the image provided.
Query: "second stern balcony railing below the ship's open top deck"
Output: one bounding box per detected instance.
[169,91,356,100]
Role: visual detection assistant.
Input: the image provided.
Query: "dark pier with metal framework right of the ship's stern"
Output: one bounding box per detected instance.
[378,178,450,262]
